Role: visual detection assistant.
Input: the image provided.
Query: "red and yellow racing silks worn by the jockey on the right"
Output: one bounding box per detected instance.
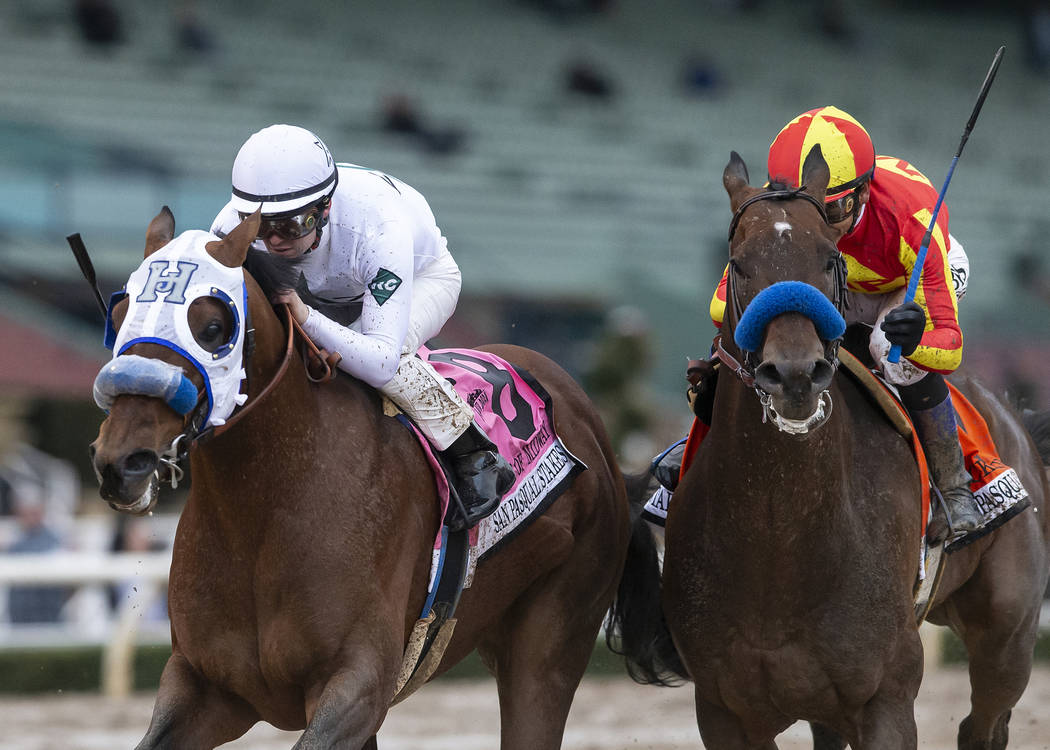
[711,157,963,375]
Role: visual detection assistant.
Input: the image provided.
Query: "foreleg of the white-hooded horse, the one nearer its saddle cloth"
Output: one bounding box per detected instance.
[292,665,394,750]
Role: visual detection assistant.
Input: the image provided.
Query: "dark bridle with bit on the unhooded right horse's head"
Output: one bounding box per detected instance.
[713,185,849,432]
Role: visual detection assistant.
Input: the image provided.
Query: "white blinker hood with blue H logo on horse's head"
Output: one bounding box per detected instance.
[107,230,248,426]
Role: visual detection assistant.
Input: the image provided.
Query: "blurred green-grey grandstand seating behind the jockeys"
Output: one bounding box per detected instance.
[0,0,1050,493]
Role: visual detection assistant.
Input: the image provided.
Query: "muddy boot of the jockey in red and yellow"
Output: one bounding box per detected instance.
[909,388,983,542]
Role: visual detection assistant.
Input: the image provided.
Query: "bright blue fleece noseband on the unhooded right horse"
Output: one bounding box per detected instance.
[733,282,846,352]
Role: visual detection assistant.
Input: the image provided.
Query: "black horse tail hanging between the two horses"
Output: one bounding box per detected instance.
[605,473,689,686]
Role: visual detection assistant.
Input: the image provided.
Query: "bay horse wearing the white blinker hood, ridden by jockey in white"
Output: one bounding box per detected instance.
[91,207,630,750]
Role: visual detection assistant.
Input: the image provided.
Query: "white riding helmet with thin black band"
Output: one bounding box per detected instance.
[233,125,339,215]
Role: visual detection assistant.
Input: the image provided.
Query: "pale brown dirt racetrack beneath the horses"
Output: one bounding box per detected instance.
[6,666,1050,750]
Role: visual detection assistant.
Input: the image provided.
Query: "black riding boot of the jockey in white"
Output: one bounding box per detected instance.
[441,422,515,532]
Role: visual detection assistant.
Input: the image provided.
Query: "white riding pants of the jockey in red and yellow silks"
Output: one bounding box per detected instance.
[845,234,970,386]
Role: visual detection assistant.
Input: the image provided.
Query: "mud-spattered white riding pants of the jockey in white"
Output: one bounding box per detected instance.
[379,253,474,451]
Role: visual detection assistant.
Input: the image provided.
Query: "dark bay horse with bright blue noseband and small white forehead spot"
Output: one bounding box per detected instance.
[607,147,1050,750]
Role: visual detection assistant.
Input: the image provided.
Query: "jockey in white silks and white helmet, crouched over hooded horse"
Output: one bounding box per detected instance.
[211,125,515,529]
